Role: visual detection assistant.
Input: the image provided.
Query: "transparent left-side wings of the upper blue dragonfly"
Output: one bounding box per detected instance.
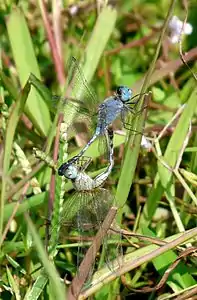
[52,57,98,149]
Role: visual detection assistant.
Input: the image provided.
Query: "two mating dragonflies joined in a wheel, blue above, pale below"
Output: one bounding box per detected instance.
[53,57,145,278]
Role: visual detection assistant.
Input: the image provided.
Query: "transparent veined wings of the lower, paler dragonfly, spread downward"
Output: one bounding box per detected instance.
[61,188,113,277]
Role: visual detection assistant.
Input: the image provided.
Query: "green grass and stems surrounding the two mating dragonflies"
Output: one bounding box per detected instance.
[0,0,197,300]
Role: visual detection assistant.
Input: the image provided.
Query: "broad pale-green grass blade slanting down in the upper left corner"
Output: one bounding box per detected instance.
[6,8,51,136]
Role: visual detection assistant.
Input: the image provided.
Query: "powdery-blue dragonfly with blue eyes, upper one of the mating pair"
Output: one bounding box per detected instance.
[58,57,144,176]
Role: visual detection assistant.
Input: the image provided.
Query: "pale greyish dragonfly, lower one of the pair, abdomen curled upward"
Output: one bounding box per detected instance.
[57,129,121,276]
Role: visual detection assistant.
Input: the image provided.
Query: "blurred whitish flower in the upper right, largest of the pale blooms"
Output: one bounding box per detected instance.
[169,16,193,44]
